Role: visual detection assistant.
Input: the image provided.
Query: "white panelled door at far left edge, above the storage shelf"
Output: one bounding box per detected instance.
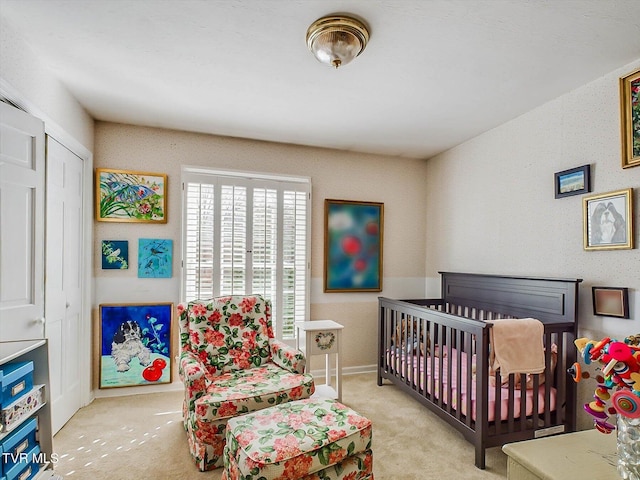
[0,102,45,341]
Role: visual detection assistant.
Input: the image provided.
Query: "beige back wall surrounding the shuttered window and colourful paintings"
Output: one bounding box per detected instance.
[94,122,427,371]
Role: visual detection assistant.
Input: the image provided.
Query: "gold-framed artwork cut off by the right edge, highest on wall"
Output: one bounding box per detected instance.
[620,68,640,168]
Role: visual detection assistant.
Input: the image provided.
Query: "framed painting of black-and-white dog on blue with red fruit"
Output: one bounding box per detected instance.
[99,303,173,388]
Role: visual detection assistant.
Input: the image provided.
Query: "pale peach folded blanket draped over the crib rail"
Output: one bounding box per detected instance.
[488,318,545,376]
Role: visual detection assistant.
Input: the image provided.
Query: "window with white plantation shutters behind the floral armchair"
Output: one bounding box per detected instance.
[182,167,311,340]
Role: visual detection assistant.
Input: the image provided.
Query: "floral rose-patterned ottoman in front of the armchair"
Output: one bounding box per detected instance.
[222,399,373,480]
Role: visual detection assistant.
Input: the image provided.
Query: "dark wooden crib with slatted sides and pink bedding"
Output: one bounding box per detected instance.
[378,272,582,468]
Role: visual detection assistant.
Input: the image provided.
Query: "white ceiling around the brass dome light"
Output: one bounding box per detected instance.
[0,0,640,158]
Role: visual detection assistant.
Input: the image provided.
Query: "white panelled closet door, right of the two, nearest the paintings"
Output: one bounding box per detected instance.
[45,136,85,434]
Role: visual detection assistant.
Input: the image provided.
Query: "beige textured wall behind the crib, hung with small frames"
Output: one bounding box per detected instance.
[425,60,640,428]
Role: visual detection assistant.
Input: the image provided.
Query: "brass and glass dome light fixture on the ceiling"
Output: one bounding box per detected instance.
[307,15,369,68]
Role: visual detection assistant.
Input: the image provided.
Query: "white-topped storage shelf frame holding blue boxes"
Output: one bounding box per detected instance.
[0,339,53,480]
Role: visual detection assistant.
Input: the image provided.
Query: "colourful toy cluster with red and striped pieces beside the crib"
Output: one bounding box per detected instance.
[567,334,640,433]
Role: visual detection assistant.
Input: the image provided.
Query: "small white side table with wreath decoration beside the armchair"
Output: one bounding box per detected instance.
[296,320,344,402]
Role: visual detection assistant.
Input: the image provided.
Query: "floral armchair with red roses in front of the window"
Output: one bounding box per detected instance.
[177,295,315,471]
